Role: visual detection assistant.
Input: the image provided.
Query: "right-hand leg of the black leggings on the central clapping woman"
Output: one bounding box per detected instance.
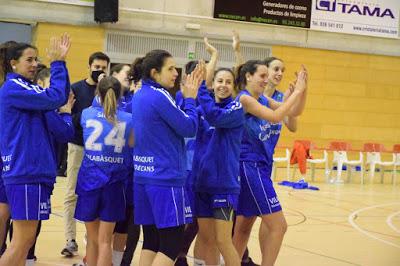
[159,225,185,261]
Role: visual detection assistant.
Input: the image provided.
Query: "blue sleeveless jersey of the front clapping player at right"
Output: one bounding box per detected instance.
[237,90,272,163]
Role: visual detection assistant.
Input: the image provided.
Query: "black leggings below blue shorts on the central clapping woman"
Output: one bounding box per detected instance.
[143,225,185,261]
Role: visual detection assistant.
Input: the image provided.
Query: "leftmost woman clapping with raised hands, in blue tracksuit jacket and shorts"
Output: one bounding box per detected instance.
[0,34,70,266]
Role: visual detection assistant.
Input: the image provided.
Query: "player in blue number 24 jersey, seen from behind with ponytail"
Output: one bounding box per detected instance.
[75,77,133,266]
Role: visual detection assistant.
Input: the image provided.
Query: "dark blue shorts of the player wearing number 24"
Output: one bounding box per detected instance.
[75,181,126,222]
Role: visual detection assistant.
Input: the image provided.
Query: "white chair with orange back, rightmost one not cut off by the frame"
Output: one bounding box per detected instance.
[364,143,396,184]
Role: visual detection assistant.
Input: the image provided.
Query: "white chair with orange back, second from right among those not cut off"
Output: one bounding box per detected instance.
[330,141,364,184]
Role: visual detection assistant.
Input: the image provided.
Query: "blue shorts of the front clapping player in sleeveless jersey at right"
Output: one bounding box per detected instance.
[237,162,282,217]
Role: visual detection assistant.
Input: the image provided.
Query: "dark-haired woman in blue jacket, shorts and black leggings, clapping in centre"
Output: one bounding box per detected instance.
[132,50,205,266]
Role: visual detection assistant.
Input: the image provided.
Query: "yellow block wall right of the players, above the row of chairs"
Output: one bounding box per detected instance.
[272,46,400,156]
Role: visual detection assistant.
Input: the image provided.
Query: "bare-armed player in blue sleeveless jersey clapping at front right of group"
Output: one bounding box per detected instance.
[233,60,307,265]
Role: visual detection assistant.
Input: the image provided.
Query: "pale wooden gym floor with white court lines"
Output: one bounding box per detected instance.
[21,171,400,266]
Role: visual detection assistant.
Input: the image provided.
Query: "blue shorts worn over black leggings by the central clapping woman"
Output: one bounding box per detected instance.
[133,183,193,229]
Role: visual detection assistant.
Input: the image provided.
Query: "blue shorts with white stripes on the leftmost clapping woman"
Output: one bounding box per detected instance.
[5,183,53,221]
